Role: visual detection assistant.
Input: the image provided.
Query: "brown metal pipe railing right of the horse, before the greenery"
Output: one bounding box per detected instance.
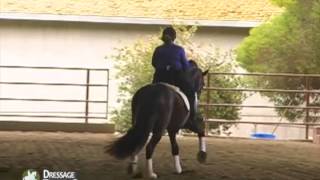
[200,72,320,139]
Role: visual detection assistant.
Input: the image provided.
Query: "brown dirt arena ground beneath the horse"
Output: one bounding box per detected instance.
[0,132,320,180]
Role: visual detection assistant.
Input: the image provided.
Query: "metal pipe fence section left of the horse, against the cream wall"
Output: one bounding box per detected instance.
[0,66,109,124]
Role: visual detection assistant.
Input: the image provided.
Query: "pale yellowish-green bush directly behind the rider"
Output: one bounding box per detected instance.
[110,26,244,131]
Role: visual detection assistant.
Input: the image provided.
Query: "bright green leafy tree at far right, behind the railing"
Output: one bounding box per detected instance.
[237,0,320,121]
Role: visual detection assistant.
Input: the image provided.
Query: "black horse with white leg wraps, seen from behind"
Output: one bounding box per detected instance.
[106,64,208,178]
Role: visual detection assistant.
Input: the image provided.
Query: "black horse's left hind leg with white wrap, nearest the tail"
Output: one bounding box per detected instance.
[146,132,162,179]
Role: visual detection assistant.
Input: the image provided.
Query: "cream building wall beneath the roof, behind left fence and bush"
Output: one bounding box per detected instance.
[0,20,248,122]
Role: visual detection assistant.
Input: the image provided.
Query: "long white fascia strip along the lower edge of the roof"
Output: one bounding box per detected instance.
[0,12,262,28]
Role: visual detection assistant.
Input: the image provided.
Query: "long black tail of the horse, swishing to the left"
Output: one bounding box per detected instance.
[106,88,155,159]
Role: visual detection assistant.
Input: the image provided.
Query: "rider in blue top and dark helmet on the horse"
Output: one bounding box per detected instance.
[152,27,196,128]
